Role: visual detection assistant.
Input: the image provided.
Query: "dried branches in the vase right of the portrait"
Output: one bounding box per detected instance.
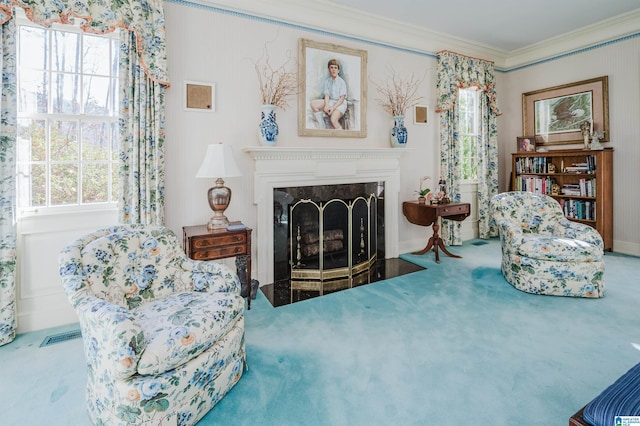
[373,69,422,116]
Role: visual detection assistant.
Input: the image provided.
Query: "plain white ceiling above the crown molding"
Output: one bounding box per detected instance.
[330,0,640,52]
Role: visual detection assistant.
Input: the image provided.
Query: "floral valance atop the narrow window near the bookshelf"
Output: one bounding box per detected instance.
[436,50,502,115]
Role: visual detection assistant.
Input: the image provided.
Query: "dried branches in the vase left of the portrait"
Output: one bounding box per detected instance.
[253,46,298,110]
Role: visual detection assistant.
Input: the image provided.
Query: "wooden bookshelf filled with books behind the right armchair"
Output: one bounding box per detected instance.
[511,148,613,251]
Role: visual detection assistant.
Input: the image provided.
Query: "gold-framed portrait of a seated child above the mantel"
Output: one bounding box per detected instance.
[298,39,367,138]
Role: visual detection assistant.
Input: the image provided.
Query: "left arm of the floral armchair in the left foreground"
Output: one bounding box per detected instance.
[73,288,146,379]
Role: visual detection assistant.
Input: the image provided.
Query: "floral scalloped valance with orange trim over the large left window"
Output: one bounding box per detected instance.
[0,0,169,87]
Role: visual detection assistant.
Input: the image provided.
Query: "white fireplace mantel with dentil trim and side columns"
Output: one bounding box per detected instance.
[243,146,410,285]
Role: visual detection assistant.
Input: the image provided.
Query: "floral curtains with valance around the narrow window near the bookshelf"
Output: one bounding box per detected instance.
[436,51,501,245]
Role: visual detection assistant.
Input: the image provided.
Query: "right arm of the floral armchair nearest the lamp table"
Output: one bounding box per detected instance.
[183,259,240,294]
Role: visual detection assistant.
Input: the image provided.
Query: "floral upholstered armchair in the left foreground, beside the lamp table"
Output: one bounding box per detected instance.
[59,225,245,425]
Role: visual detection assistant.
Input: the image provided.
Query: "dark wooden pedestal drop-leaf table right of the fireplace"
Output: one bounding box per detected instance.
[402,201,471,263]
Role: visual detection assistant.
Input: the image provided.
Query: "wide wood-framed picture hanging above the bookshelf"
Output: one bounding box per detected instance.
[522,76,609,145]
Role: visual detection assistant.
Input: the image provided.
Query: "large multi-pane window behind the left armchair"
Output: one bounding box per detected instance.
[16,15,118,212]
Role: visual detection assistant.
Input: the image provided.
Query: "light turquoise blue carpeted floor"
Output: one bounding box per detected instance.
[0,239,640,426]
